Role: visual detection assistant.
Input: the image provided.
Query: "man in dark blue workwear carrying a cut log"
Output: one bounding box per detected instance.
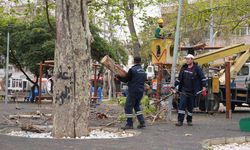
[116,57,146,130]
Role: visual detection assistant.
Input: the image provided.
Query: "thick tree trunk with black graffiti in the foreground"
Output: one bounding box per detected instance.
[52,0,91,137]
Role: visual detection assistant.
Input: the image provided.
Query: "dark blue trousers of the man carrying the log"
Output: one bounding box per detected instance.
[124,92,145,126]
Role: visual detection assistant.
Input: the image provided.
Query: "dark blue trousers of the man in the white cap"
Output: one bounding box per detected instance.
[178,94,195,122]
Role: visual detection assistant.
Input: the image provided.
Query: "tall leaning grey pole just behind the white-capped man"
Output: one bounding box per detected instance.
[167,0,182,120]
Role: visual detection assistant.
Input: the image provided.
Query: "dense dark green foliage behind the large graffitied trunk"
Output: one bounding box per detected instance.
[0,16,128,73]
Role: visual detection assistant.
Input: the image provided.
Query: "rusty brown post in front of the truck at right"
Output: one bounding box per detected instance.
[225,61,232,119]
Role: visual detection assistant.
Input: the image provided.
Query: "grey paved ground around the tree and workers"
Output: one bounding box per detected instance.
[0,103,250,150]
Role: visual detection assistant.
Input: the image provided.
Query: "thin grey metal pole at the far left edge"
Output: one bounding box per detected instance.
[5,27,10,104]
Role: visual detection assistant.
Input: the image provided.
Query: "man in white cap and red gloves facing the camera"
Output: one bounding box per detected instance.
[175,54,207,126]
